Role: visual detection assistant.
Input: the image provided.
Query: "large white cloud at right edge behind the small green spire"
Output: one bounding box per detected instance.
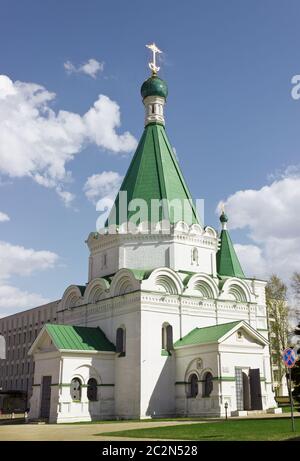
[219,166,300,281]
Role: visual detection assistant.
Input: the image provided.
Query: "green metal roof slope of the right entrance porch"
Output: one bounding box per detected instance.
[174,320,241,347]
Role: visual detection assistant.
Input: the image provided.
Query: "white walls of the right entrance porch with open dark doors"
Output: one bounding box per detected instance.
[176,324,276,416]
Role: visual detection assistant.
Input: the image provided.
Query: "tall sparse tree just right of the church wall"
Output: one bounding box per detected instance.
[266,274,288,395]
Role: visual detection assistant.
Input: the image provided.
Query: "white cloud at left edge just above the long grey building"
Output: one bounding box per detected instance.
[0,241,58,316]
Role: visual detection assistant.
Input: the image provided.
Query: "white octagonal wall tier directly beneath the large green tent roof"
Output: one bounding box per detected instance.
[87,225,218,281]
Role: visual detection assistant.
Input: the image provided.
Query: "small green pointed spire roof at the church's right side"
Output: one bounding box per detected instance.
[217,229,245,278]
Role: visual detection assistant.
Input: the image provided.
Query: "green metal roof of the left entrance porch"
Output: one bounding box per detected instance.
[45,324,116,351]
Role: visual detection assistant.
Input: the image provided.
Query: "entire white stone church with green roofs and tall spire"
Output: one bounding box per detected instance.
[5,45,276,423]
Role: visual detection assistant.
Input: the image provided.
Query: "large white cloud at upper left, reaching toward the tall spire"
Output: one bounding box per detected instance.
[0,75,136,204]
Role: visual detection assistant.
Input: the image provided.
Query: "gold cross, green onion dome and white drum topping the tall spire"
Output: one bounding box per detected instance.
[141,43,168,125]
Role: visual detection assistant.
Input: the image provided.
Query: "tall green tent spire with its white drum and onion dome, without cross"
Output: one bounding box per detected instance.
[106,54,200,225]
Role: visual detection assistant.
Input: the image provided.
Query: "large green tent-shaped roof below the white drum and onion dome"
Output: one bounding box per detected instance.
[105,123,200,226]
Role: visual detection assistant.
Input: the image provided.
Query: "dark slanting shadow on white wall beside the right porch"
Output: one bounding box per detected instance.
[146,351,176,418]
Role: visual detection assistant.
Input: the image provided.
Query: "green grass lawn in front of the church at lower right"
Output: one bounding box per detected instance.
[97,418,300,441]
